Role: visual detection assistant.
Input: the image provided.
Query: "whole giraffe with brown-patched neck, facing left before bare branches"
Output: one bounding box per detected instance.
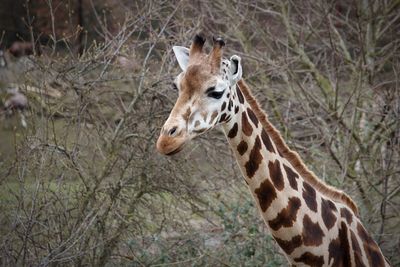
[157,35,390,267]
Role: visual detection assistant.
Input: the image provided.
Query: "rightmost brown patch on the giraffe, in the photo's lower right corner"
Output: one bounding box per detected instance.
[357,223,385,267]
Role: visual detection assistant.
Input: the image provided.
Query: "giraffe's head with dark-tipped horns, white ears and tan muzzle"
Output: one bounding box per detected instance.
[157,35,242,155]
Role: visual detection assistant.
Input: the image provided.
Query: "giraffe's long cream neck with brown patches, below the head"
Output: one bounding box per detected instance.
[219,81,389,267]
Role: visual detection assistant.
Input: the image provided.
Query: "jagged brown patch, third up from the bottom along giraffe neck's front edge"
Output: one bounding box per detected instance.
[268,197,301,231]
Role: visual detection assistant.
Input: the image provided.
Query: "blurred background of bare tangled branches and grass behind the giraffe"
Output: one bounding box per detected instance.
[0,0,400,266]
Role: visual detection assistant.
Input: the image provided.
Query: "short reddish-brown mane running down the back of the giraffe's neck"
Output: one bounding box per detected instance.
[237,79,359,216]
